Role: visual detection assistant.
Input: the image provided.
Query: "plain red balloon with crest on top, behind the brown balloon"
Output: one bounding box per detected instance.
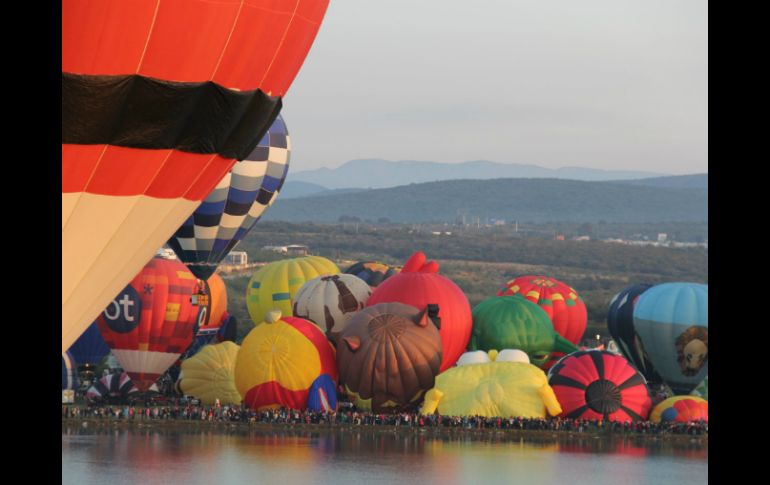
[366,251,473,372]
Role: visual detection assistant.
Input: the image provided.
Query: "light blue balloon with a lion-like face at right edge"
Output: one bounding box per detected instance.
[634,283,708,394]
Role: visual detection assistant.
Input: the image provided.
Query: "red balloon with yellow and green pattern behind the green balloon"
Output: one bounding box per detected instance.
[497,275,588,345]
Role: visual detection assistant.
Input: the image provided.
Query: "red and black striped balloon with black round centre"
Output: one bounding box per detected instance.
[548,350,652,422]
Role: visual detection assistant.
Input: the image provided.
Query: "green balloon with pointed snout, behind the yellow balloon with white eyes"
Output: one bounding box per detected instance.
[468,295,578,368]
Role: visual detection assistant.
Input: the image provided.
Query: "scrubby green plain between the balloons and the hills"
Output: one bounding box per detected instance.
[219,223,708,342]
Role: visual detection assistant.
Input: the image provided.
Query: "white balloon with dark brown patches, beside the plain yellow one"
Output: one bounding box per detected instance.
[293,274,372,335]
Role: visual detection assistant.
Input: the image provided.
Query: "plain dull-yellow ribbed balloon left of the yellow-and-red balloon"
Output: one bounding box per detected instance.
[179,342,241,406]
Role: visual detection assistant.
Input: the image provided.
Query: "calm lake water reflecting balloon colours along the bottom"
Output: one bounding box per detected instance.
[62,424,708,485]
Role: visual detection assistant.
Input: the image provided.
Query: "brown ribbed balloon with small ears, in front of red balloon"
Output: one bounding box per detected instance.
[337,303,441,413]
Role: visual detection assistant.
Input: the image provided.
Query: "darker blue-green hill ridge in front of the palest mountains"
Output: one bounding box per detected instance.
[264,179,708,223]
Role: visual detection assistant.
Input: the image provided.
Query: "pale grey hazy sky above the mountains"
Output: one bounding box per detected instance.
[282,0,708,174]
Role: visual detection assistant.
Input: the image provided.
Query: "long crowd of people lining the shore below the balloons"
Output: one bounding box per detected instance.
[62,404,708,435]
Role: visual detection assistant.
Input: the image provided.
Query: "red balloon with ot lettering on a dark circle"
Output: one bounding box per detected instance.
[96,258,199,392]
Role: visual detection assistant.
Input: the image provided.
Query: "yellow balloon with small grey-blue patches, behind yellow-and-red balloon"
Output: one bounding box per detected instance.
[246,256,340,325]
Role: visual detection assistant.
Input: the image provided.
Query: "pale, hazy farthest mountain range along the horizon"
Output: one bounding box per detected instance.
[290,159,666,189]
